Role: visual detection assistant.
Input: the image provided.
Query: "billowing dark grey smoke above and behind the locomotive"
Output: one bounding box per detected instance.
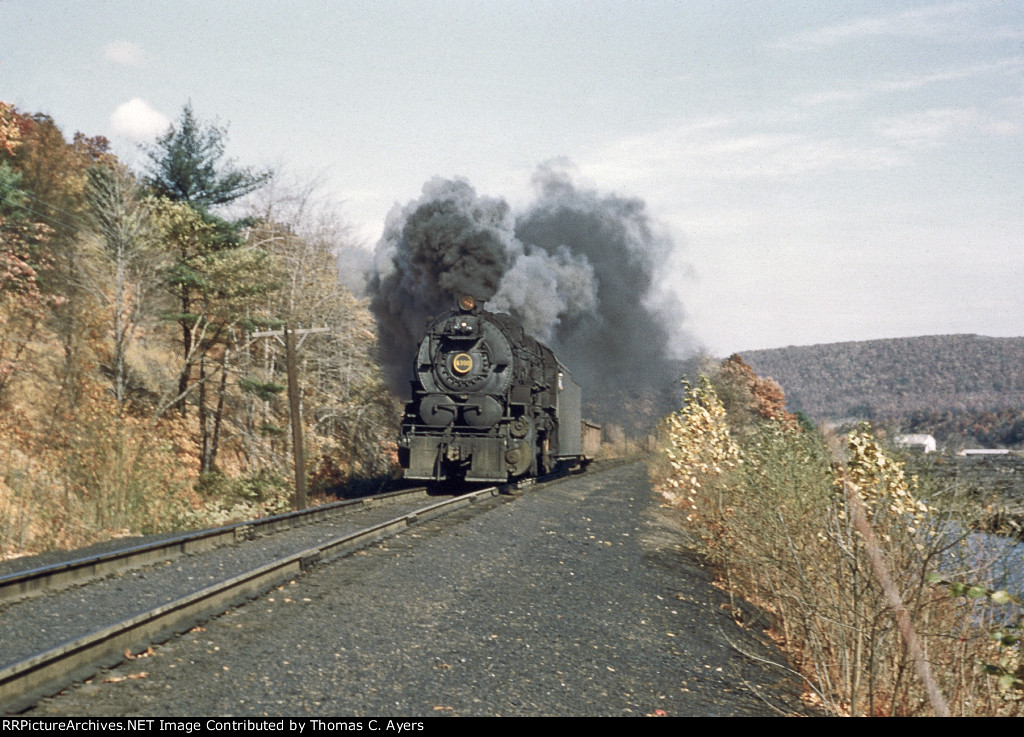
[369,167,685,429]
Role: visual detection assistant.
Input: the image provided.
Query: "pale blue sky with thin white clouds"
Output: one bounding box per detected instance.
[0,0,1024,355]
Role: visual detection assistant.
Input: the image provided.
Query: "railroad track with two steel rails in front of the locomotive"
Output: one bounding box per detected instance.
[0,487,512,713]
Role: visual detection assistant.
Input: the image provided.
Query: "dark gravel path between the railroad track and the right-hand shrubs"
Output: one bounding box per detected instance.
[29,464,800,717]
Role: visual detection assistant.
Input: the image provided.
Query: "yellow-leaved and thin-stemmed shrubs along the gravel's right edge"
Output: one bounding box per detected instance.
[655,381,1021,716]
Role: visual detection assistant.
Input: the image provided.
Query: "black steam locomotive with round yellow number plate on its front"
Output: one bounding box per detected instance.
[398,295,600,483]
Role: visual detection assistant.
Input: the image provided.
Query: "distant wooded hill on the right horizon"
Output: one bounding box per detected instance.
[741,335,1024,445]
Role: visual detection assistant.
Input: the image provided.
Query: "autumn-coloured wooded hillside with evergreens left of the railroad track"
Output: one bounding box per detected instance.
[0,104,399,556]
